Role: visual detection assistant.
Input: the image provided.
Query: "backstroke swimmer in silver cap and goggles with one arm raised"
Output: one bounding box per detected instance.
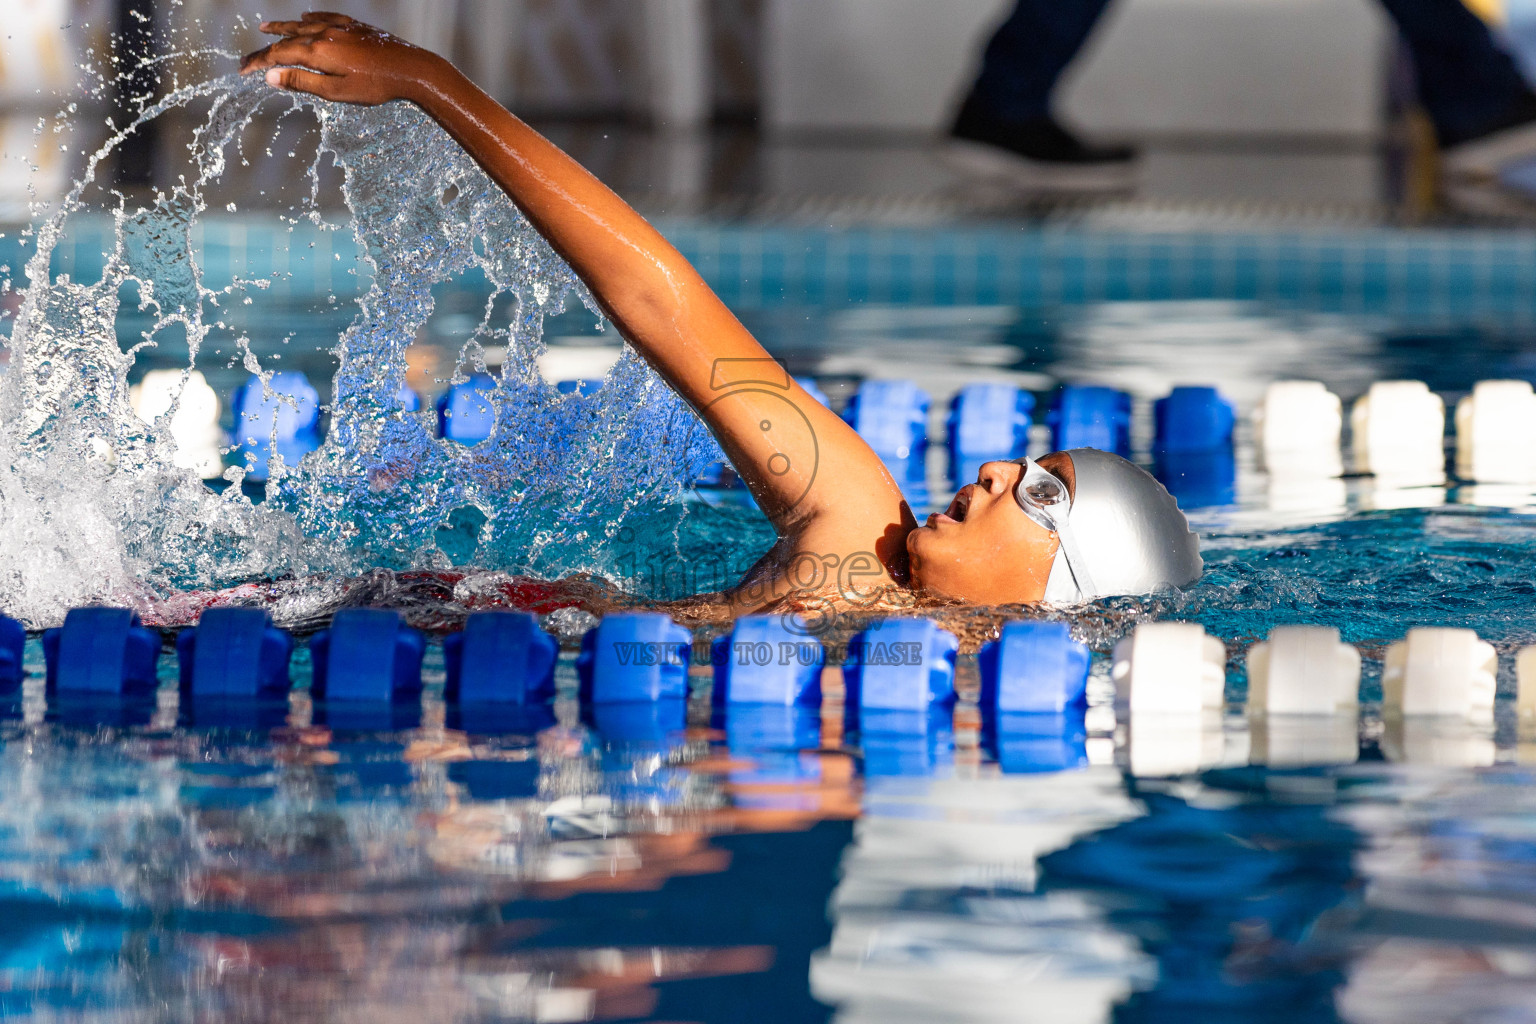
[241,12,1201,614]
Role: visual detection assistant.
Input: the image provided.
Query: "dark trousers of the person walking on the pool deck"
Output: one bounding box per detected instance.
[971,0,1528,144]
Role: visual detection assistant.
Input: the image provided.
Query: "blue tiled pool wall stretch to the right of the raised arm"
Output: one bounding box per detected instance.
[668,226,1536,315]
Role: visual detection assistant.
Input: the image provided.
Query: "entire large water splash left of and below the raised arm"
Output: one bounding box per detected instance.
[0,77,719,625]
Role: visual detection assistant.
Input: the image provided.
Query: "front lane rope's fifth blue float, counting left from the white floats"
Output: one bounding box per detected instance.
[442,611,561,705]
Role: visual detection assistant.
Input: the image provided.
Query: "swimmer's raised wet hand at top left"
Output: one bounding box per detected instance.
[240,11,452,106]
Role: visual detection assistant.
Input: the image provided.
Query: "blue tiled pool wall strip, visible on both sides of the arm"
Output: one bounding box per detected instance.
[9,215,1536,321]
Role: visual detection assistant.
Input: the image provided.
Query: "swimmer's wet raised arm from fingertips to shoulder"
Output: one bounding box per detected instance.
[241,14,915,573]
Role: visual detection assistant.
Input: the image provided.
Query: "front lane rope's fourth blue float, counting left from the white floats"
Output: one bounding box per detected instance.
[576,611,693,705]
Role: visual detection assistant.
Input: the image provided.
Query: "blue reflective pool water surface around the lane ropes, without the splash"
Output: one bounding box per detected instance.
[0,277,1536,1021]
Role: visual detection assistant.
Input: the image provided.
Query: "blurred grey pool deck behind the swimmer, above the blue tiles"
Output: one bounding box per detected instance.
[14,111,1536,227]
